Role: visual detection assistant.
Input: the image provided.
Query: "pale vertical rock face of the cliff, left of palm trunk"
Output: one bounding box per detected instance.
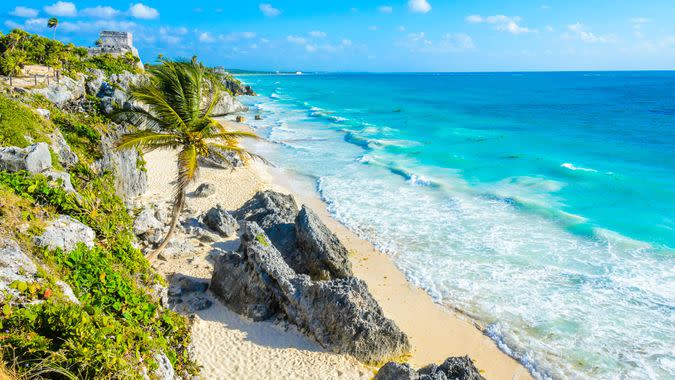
[95,127,148,202]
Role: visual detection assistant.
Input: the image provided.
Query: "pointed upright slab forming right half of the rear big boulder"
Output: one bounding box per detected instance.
[295,205,353,279]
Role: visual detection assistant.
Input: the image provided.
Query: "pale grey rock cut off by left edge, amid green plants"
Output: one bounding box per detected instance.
[0,238,37,300]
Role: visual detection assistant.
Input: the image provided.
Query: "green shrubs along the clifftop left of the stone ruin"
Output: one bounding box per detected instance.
[0,27,139,76]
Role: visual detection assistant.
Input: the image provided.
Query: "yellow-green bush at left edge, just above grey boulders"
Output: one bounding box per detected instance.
[0,95,53,148]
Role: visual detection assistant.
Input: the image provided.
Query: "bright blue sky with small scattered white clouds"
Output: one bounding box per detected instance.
[0,0,675,72]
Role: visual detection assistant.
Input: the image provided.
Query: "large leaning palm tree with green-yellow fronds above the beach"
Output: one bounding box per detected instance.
[114,60,260,260]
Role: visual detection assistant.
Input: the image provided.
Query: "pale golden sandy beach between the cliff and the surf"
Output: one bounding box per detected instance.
[137,122,531,379]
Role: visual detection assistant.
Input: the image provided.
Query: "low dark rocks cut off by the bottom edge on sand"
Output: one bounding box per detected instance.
[374,356,485,380]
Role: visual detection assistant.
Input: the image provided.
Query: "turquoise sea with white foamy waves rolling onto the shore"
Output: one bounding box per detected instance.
[235,72,675,379]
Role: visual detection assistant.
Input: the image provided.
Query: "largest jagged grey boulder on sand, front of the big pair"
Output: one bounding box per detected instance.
[211,223,410,362]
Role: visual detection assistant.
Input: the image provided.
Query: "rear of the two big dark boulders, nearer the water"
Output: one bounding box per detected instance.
[234,190,352,280]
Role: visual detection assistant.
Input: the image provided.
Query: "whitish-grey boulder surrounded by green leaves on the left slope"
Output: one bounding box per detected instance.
[35,215,96,252]
